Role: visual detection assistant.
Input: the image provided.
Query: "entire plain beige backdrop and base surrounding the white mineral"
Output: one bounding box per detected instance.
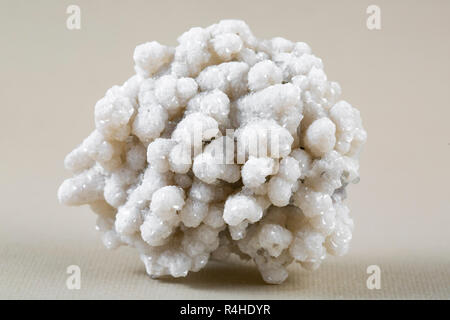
[0,0,450,299]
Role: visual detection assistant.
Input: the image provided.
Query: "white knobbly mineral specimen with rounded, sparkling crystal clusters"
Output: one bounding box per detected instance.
[58,20,367,283]
